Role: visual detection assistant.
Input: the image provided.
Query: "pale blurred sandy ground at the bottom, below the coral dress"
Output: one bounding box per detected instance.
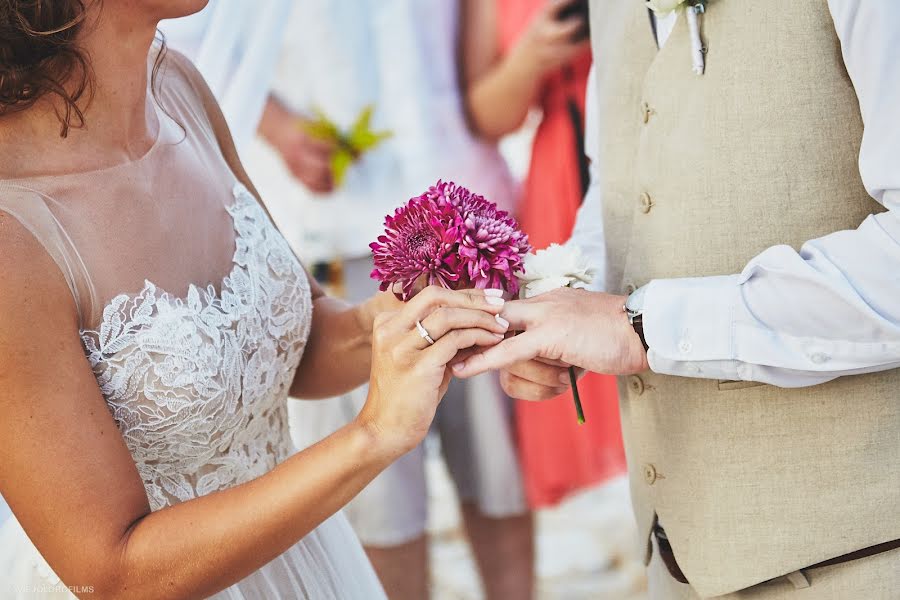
[427,455,646,600]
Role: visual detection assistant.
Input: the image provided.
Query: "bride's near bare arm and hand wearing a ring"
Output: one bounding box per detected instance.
[0,218,501,600]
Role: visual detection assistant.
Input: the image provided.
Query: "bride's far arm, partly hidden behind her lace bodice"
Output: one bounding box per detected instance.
[167,50,401,399]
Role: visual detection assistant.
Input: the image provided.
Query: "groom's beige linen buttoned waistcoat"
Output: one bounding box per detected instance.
[591,0,900,597]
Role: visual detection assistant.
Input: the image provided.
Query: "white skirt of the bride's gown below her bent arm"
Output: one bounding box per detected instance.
[0,513,386,600]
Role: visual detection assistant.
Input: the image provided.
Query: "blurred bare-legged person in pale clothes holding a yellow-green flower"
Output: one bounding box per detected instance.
[239,0,534,600]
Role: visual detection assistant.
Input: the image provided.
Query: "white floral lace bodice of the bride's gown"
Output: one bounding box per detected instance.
[82,184,312,510]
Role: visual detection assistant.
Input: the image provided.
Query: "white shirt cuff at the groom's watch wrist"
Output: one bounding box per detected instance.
[643,275,743,380]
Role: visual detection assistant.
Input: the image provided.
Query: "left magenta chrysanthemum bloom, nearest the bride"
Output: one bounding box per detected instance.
[369,197,462,300]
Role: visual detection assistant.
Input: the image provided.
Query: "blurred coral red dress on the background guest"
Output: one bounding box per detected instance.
[498,0,625,508]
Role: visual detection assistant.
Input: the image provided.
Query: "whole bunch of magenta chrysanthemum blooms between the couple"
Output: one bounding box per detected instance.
[371,181,531,300]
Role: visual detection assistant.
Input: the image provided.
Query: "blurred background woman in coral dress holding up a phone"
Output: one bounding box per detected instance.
[464,0,625,507]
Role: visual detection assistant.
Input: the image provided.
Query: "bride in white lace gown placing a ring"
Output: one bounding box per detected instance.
[0,0,505,600]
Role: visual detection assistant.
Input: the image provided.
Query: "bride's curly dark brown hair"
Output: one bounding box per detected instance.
[0,0,165,137]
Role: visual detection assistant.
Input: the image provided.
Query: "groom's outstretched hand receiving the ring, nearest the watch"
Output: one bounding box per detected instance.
[453,288,647,383]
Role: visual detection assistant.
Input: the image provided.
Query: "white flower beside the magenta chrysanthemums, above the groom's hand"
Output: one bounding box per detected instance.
[517,244,596,298]
